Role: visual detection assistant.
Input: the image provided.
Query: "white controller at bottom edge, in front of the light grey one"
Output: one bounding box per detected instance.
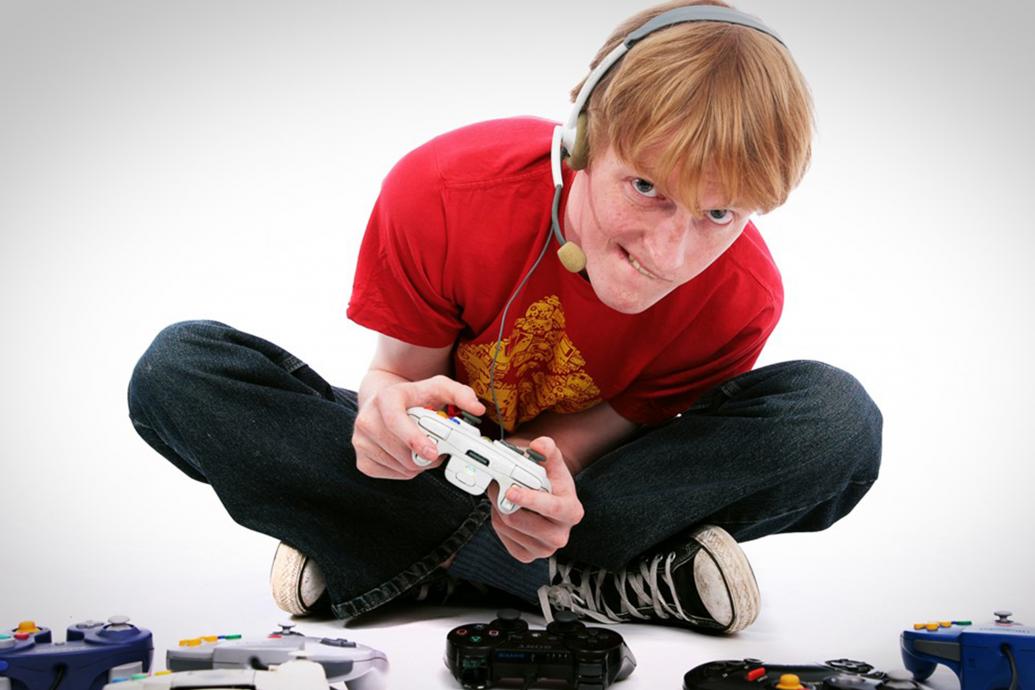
[101,660,328,690]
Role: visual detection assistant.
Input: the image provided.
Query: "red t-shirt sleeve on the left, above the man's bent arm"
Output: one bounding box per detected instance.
[347,143,463,348]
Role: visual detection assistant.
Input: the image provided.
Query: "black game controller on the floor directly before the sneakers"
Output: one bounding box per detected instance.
[445,609,637,690]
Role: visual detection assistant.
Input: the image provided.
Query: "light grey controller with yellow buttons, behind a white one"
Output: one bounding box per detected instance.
[166,623,388,690]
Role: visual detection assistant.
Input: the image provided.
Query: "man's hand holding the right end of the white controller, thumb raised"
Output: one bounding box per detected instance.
[487,437,585,563]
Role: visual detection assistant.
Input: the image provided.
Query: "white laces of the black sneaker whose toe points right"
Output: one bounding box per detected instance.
[538,553,690,623]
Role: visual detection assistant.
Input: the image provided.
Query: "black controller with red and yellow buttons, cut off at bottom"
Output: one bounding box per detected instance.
[683,659,920,690]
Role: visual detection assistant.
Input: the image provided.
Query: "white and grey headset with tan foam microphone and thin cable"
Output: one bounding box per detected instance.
[489,5,786,438]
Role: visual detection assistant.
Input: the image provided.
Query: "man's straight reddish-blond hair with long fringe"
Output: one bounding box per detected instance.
[571,0,812,215]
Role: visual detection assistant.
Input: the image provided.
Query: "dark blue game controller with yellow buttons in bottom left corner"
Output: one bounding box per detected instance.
[0,616,154,690]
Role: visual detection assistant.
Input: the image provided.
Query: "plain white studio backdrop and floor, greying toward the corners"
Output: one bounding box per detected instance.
[0,0,1035,690]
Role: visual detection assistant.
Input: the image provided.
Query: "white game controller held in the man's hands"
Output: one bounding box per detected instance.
[406,408,551,514]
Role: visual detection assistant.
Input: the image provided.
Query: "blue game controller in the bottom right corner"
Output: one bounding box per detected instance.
[901,611,1035,690]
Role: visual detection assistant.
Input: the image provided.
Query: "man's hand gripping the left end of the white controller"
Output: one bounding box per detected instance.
[352,376,485,479]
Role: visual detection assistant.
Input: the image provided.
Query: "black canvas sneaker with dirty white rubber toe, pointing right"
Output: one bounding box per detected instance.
[539,524,761,633]
